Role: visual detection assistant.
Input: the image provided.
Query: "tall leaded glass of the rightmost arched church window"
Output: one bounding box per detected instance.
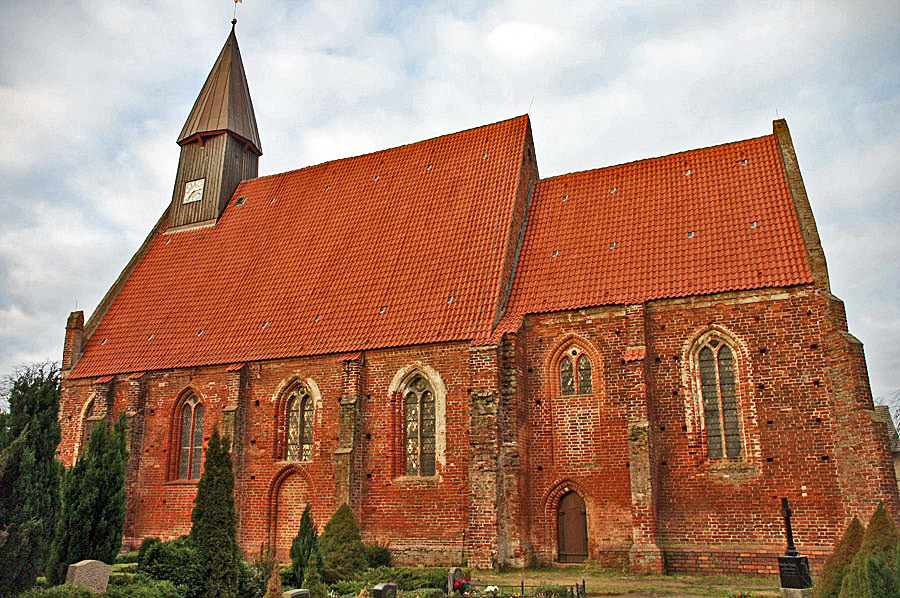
[697,337,741,459]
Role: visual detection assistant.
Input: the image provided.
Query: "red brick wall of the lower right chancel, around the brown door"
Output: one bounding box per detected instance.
[519,286,900,573]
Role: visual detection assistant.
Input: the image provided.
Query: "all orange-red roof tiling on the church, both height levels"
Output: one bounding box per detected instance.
[71,116,812,378]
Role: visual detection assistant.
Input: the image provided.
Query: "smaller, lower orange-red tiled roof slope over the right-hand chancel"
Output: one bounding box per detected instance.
[494,135,813,337]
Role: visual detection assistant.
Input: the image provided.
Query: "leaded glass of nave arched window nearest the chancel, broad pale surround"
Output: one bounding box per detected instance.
[404,376,435,476]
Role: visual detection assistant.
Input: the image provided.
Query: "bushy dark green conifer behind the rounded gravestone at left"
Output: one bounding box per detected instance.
[47,417,127,584]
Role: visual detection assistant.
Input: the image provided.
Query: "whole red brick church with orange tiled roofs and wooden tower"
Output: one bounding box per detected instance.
[59,28,900,573]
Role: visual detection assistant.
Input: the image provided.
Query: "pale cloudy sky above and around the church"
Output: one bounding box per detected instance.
[0,0,900,401]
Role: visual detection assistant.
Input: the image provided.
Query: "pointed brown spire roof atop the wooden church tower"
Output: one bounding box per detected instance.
[178,22,262,155]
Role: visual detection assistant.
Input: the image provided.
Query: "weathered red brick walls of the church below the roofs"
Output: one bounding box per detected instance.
[60,284,900,573]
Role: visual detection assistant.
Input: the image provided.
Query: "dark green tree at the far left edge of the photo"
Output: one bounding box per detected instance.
[0,364,62,596]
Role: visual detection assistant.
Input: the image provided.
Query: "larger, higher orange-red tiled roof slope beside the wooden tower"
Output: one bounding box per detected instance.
[70,116,529,378]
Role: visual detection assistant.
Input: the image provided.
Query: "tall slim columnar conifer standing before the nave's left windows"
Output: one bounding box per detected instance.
[190,427,240,598]
